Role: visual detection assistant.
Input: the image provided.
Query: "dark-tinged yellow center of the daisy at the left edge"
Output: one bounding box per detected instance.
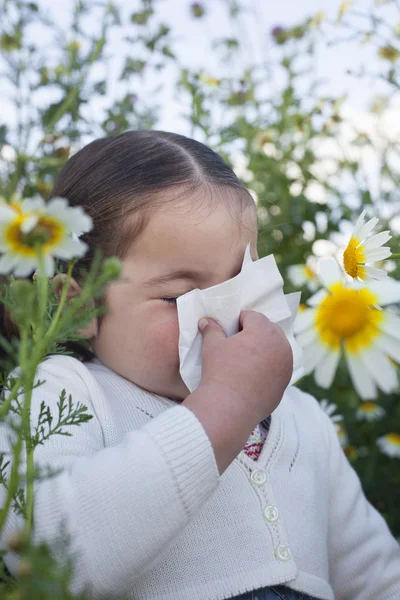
[5,214,65,257]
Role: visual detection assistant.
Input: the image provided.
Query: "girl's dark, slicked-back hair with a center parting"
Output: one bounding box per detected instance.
[0,130,254,364]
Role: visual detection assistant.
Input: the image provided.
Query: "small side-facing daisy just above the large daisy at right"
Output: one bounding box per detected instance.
[343,210,392,281]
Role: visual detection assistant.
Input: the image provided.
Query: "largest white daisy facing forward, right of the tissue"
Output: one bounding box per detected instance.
[293,257,400,400]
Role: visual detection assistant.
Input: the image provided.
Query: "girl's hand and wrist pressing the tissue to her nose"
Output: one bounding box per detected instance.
[183,311,293,473]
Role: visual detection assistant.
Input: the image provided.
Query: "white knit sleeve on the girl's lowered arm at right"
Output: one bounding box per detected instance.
[321,411,400,600]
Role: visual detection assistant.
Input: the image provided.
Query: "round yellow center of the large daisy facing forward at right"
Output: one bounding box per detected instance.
[315,283,383,353]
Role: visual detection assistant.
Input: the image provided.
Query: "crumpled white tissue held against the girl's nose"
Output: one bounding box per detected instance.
[177,244,304,392]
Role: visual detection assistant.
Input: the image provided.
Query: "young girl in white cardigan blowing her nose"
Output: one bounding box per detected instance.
[0,131,400,600]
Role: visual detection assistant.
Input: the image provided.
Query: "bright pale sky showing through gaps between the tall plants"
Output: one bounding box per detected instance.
[0,0,400,237]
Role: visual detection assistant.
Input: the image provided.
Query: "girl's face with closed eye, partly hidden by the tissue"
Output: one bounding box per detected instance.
[92,192,258,400]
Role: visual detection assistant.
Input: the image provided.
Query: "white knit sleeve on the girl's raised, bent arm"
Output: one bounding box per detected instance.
[0,359,219,600]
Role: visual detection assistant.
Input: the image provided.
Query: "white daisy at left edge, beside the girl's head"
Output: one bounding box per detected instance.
[0,197,92,277]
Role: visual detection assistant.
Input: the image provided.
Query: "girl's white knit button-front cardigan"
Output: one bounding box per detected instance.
[0,356,400,600]
